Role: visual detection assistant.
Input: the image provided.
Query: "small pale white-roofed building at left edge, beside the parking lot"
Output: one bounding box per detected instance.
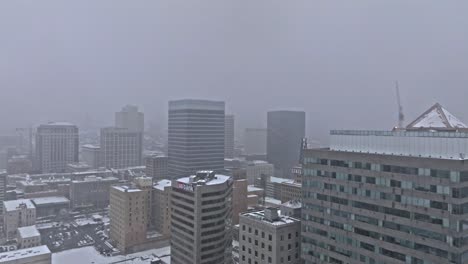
[3,199,36,240]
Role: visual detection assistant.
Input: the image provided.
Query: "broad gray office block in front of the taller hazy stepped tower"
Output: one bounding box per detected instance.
[101,127,143,169]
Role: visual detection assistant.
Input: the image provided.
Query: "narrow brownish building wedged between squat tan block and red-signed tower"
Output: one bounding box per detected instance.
[151,180,172,237]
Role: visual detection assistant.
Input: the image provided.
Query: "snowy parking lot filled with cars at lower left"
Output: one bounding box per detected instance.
[40,217,117,256]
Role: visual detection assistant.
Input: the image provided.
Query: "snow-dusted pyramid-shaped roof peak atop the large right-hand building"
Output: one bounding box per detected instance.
[406,103,468,129]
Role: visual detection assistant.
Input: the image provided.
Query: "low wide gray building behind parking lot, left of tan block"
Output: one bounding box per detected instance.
[70,176,119,209]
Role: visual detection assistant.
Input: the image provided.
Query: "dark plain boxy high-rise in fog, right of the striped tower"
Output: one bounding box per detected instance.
[267,111,305,177]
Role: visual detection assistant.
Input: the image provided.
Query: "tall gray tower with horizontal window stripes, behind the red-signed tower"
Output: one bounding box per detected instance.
[168,99,225,178]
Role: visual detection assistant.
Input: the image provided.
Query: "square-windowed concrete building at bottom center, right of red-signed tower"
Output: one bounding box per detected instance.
[239,208,302,264]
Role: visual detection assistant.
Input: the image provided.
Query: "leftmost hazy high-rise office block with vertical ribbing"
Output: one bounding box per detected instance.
[36,122,79,173]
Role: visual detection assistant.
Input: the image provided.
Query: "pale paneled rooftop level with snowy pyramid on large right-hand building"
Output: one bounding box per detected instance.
[330,104,468,160]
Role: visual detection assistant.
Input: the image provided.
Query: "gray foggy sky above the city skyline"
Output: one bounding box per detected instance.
[0,0,468,144]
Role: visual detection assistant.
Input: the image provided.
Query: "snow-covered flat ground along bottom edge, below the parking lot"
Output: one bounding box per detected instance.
[52,247,171,264]
